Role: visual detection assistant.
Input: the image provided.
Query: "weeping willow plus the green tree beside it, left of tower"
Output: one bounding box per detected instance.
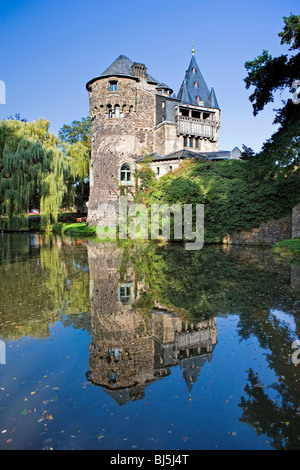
[0,116,90,231]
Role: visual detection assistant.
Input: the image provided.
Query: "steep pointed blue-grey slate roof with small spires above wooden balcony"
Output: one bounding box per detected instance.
[177,53,219,109]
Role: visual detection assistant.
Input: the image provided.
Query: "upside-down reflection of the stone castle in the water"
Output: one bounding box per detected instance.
[87,243,217,405]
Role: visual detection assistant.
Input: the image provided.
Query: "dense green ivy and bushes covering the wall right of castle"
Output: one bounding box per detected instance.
[146,157,300,243]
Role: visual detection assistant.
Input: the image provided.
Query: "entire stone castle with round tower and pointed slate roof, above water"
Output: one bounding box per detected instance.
[86,49,241,224]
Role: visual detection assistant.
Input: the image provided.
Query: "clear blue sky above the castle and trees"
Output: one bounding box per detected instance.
[0,0,300,151]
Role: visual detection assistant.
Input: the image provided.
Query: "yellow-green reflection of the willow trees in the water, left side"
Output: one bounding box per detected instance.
[0,234,89,340]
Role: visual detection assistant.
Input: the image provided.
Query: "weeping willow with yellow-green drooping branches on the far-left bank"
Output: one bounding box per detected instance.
[0,119,73,230]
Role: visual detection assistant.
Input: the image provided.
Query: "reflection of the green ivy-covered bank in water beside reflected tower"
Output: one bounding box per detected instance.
[118,244,299,324]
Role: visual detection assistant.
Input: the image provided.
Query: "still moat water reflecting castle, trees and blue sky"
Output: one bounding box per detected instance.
[0,234,300,451]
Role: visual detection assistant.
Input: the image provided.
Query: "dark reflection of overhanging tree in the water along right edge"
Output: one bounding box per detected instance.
[232,246,300,449]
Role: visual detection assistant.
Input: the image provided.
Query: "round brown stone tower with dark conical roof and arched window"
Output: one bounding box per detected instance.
[86,55,163,224]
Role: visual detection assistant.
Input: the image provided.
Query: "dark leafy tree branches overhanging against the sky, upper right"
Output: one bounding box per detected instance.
[244,14,300,170]
